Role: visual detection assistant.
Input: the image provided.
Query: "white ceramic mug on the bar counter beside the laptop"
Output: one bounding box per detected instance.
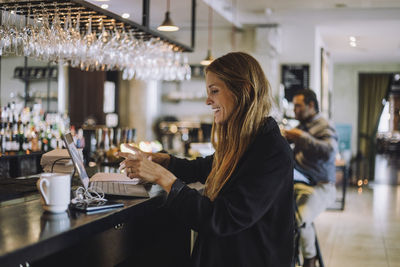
[36,173,71,213]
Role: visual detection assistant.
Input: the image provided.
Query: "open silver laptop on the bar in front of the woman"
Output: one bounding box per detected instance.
[63,133,149,197]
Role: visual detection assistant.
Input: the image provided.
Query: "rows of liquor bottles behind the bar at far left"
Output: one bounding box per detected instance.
[0,103,69,156]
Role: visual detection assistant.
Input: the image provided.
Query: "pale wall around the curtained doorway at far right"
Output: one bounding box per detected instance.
[332,63,400,155]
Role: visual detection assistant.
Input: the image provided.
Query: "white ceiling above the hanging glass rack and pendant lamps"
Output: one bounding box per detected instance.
[89,0,400,63]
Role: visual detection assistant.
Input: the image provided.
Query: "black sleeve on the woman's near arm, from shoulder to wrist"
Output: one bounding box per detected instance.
[167,132,293,236]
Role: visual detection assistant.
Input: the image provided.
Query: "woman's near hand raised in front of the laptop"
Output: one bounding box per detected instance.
[117,146,176,193]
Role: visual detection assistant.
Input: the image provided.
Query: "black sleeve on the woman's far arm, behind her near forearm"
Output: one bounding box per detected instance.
[168,156,213,184]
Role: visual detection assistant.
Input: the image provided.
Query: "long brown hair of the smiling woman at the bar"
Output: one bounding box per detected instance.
[204,52,272,200]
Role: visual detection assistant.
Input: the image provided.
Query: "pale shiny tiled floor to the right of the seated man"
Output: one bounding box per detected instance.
[315,184,400,267]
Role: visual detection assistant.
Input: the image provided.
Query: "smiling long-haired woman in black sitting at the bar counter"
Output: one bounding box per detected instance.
[120,52,294,267]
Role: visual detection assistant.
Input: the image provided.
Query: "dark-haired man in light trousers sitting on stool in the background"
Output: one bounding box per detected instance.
[283,89,337,267]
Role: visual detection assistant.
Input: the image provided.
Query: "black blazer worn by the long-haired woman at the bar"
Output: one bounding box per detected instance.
[166,118,294,267]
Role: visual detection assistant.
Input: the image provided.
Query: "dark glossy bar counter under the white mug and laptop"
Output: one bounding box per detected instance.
[0,185,190,267]
